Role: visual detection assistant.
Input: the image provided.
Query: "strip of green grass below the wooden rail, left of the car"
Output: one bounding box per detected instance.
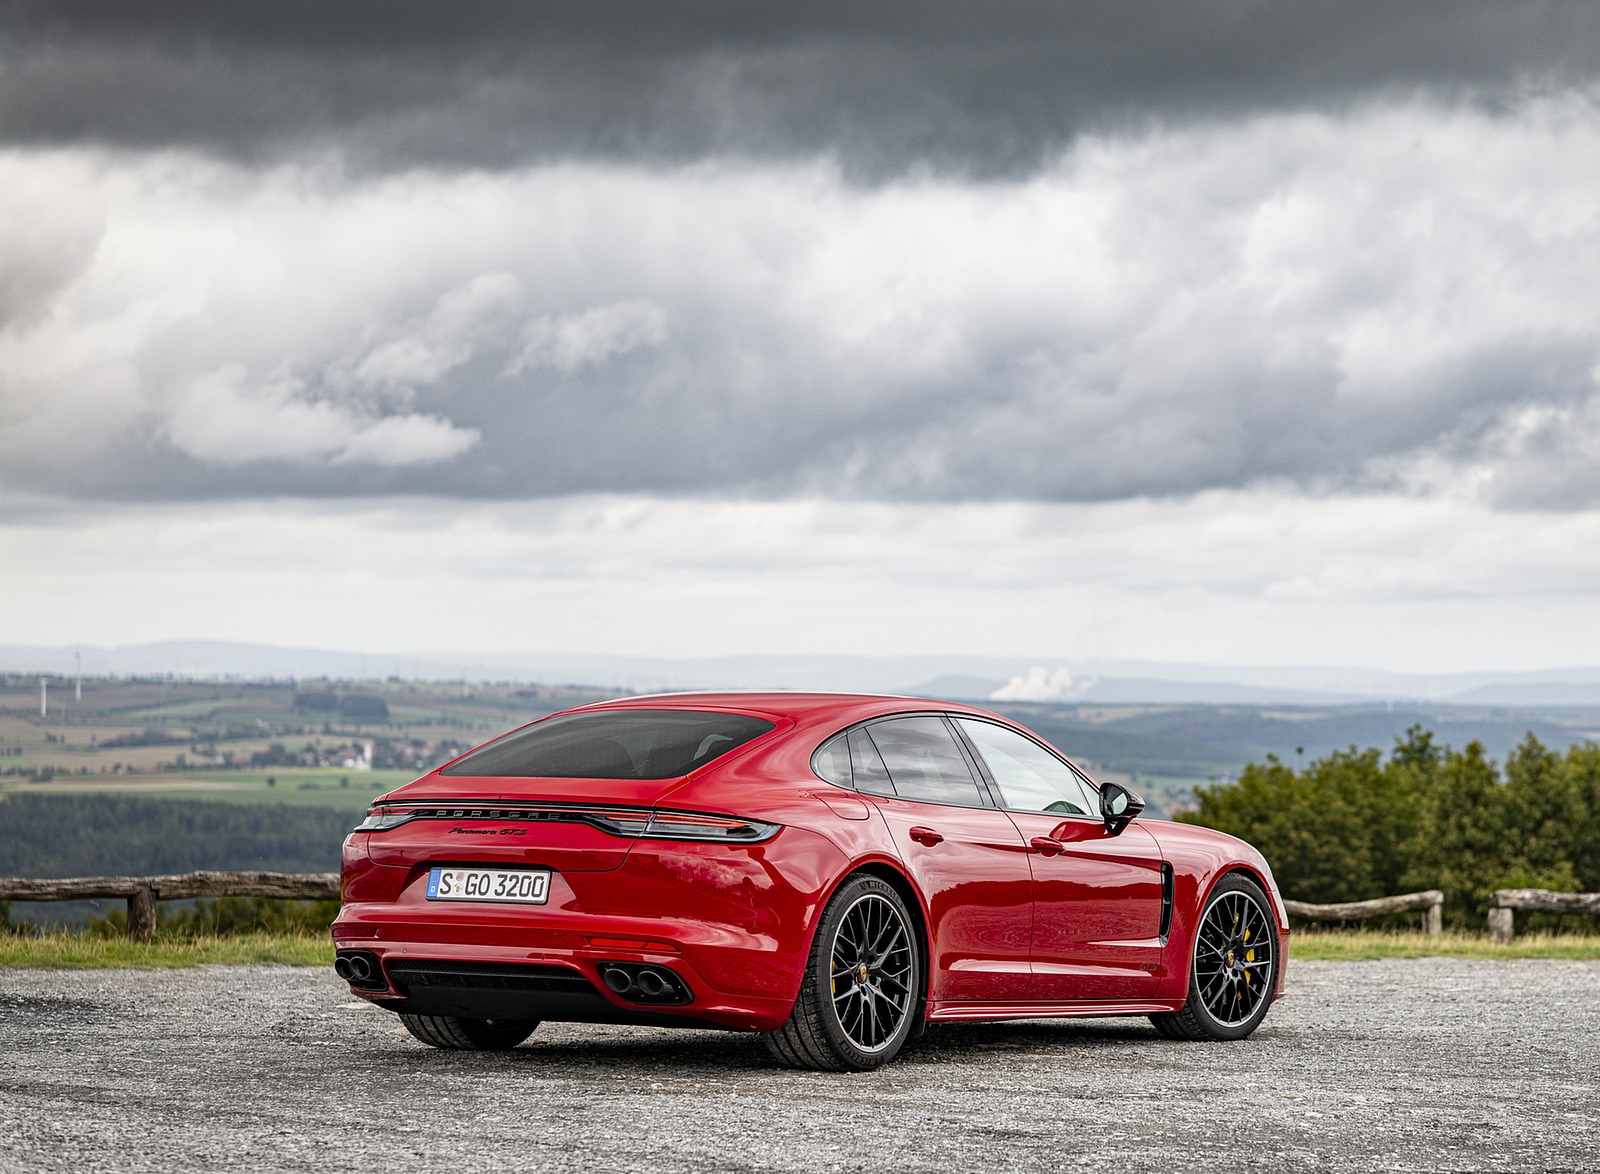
[0,931,333,971]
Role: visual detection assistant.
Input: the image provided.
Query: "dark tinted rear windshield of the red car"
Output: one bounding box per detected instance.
[440,709,773,779]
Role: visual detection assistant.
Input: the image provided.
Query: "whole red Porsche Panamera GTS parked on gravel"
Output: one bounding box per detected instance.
[333,693,1290,1070]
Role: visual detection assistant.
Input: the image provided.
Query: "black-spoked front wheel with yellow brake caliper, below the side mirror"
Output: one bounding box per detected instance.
[1150,872,1280,1040]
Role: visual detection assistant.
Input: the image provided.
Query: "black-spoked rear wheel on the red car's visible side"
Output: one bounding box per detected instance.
[766,875,922,1072]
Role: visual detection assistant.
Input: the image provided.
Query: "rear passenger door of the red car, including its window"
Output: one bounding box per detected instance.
[848,715,1034,1001]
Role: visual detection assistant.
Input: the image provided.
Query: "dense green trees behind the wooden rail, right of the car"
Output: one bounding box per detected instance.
[1176,726,1600,928]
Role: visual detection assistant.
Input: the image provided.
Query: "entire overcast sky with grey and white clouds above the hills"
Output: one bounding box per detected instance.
[0,0,1600,672]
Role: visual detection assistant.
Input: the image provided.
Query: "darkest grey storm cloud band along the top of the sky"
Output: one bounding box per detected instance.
[9,0,1600,179]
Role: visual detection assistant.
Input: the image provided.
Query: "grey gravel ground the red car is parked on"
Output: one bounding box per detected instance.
[0,958,1600,1174]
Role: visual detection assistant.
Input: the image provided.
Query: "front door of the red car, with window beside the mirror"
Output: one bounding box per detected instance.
[955,718,1163,1001]
